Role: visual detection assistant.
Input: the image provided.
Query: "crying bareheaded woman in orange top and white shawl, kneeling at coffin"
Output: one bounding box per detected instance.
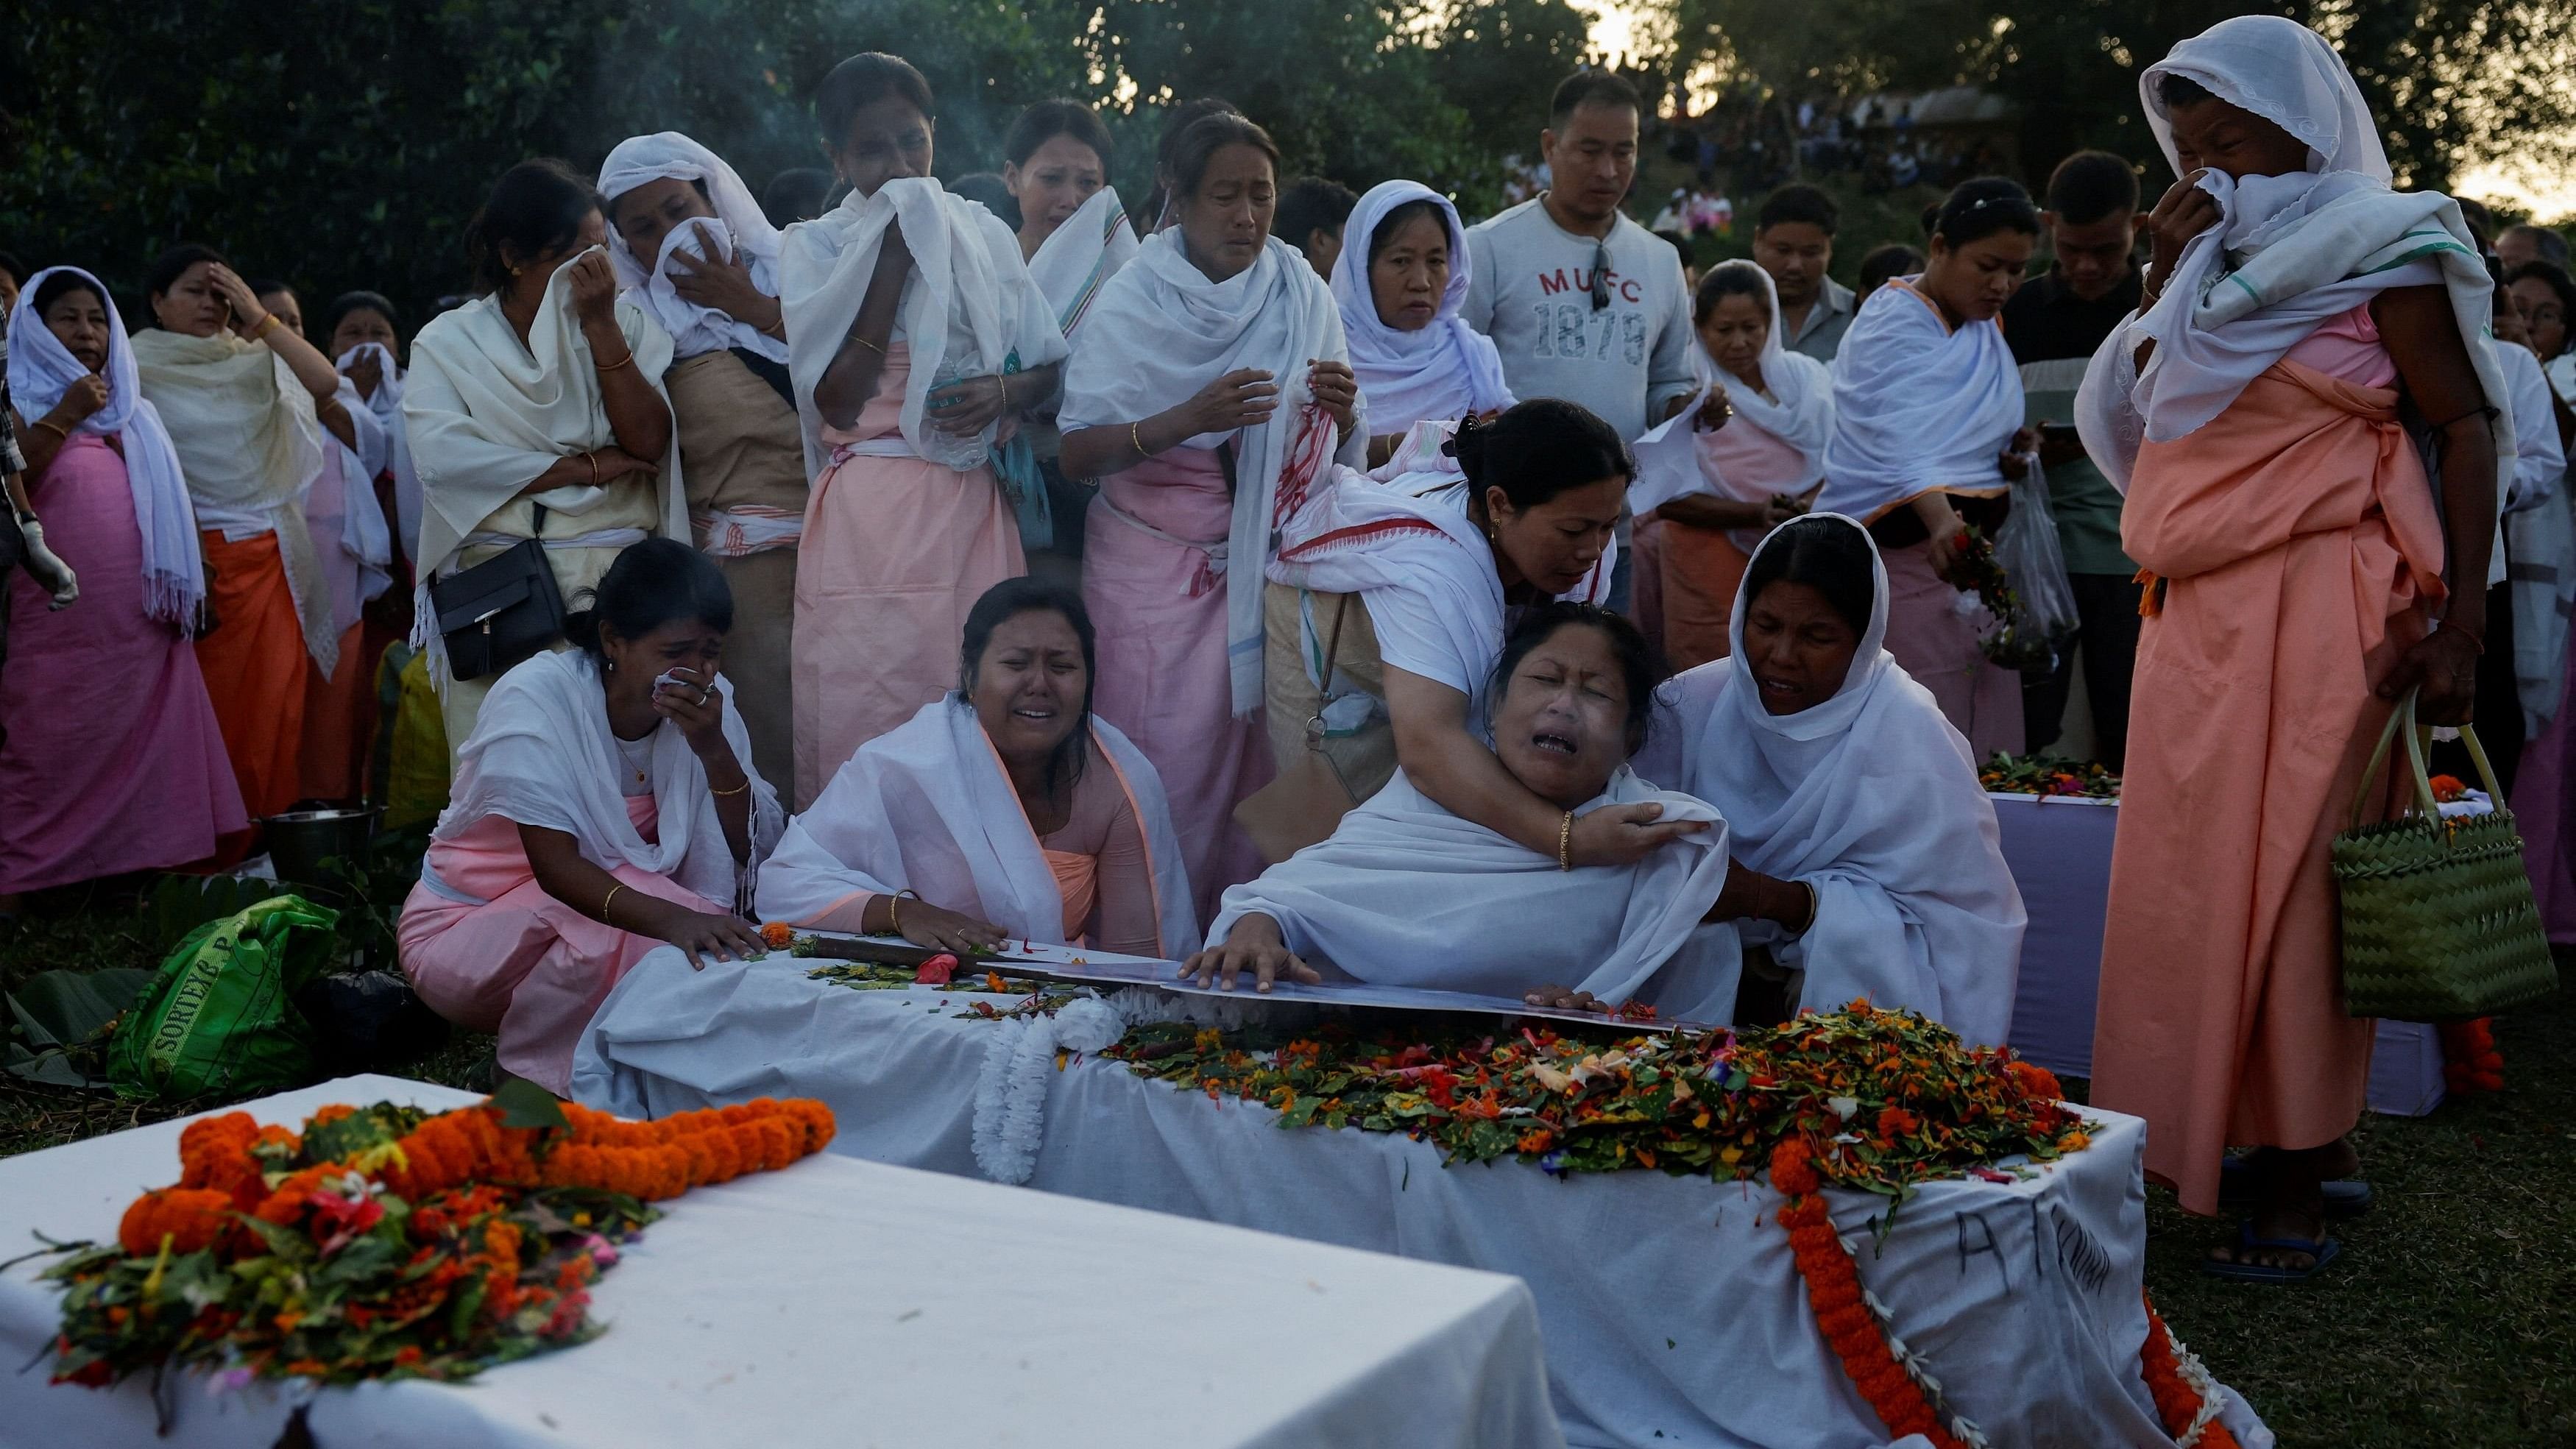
[760,579,1195,960]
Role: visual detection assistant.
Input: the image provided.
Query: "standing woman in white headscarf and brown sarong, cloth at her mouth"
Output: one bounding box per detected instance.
[601,131,807,798]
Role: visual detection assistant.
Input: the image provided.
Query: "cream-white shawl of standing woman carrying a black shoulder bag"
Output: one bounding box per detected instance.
[402,252,688,592]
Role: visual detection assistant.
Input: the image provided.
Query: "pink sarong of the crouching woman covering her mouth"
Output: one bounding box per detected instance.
[397,796,724,1097]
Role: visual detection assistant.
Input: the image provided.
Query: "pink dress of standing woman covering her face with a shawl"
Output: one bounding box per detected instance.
[793,342,1028,811]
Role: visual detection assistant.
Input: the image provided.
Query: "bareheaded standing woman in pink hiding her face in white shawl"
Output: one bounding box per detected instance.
[781,52,1064,801]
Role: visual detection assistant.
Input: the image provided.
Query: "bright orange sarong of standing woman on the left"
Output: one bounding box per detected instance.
[196,530,312,821]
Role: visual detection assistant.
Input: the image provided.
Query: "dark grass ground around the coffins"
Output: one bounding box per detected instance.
[0,888,2576,1449]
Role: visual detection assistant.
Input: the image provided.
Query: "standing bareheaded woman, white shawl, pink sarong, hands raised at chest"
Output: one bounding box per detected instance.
[1059,113,1368,911]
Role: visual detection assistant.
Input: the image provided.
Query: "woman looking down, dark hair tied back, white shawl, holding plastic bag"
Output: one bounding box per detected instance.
[1816,177,2040,759]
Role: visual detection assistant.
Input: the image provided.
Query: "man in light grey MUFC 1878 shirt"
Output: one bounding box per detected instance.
[1463,69,1698,610]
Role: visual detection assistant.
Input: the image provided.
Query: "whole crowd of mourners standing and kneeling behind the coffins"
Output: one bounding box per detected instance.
[0,18,2576,1277]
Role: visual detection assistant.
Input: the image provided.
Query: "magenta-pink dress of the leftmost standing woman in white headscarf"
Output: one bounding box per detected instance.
[0,433,250,896]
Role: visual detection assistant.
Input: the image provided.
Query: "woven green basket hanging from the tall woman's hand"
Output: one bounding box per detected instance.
[2334,695,2558,1021]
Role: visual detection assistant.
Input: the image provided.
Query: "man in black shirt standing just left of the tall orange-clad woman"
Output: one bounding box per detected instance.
[2002,152,2146,770]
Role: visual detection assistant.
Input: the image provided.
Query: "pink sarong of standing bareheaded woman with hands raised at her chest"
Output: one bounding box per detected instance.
[1082,448,1275,921]
